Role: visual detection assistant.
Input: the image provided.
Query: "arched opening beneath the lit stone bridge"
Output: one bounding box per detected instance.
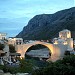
[25,44,51,61]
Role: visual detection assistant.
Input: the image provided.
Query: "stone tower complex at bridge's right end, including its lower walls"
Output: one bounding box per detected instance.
[53,29,73,57]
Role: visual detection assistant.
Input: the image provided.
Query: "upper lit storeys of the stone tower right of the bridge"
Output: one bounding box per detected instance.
[53,29,73,51]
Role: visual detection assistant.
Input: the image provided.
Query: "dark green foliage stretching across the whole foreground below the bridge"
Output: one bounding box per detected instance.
[0,55,75,75]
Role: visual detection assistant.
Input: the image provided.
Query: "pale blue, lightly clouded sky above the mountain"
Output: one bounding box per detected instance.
[0,0,75,37]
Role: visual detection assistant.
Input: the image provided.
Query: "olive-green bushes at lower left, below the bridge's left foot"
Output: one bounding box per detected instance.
[0,59,34,74]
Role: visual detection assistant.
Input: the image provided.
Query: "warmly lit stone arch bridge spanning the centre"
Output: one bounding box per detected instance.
[16,41,61,61]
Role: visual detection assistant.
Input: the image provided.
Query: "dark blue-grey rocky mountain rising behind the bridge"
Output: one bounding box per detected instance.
[16,7,75,40]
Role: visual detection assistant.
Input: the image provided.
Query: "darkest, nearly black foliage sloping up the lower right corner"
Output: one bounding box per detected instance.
[32,55,75,75]
